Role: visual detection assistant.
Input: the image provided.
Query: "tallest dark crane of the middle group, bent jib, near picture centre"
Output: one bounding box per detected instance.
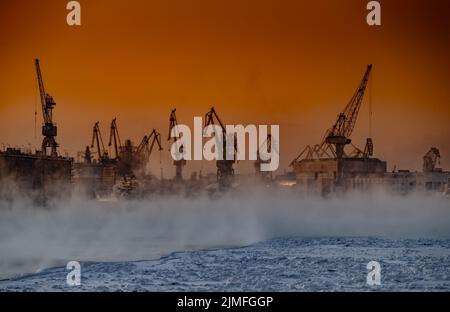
[205,107,237,187]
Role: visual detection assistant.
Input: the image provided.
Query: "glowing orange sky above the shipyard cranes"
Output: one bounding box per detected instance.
[0,0,450,175]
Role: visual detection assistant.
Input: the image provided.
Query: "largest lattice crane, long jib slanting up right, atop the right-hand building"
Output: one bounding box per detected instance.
[291,64,373,186]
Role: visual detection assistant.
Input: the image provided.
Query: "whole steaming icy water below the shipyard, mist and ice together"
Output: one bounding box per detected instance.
[0,190,450,291]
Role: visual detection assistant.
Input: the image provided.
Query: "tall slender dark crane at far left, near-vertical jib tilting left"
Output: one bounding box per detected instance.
[34,59,58,157]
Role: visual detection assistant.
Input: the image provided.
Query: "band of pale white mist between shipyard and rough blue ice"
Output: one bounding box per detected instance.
[0,186,450,277]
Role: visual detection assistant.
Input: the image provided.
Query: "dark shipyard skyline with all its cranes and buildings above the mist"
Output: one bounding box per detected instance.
[0,59,450,202]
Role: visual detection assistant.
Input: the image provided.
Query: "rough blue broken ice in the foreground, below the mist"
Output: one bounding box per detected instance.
[0,237,450,292]
